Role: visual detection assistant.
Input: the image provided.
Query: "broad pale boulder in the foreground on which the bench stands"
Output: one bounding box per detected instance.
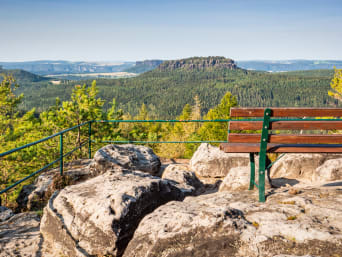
[124,188,342,257]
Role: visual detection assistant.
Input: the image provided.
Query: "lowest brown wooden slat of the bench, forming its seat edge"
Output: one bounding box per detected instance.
[220,143,342,153]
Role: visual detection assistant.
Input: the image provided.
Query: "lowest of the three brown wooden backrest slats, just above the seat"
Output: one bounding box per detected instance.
[228,133,342,144]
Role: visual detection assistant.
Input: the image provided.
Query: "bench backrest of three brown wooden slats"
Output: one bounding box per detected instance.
[228,108,342,144]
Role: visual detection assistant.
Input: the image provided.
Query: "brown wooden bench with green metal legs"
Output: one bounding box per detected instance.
[220,108,342,202]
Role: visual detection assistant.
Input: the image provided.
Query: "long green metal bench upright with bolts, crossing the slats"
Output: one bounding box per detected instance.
[258,108,271,202]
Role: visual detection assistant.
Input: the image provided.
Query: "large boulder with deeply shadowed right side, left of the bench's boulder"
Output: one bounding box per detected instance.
[41,167,184,256]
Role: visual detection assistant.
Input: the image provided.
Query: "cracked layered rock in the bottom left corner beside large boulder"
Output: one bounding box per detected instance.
[0,212,42,257]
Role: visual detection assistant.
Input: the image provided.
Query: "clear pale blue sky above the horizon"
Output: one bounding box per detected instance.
[0,0,342,61]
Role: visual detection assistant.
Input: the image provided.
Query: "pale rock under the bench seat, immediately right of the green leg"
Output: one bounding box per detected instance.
[271,154,342,182]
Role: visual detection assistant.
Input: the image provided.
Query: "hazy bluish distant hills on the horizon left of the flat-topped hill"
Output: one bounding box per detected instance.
[0,61,134,75]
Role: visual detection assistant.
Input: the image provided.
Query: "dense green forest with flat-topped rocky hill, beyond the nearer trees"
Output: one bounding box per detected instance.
[13,57,338,118]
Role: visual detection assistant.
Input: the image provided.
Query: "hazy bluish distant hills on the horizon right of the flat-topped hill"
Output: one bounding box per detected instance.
[237,60,342,72]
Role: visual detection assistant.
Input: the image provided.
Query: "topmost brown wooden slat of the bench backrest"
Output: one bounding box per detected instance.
[230,107,342,117]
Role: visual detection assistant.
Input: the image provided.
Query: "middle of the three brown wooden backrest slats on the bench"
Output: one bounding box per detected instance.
[229,120,342,130]
